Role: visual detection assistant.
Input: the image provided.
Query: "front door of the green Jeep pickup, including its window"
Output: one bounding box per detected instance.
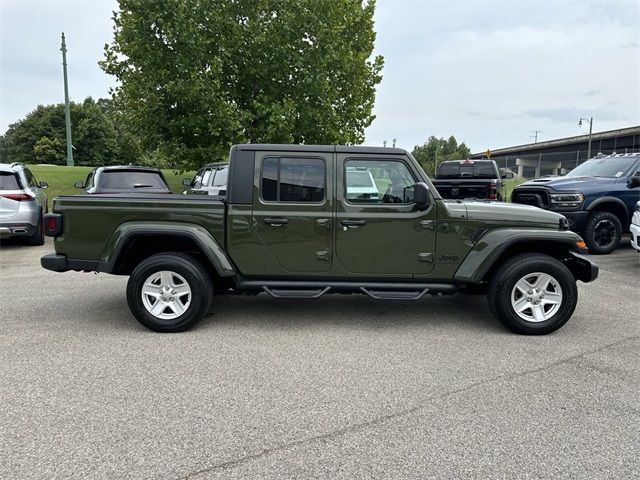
[335,154,436,277]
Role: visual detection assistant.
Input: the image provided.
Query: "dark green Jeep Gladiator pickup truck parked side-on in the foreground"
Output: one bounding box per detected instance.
[41,144,598,334]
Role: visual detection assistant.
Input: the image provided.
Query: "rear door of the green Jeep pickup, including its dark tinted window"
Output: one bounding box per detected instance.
[252,152,333,275]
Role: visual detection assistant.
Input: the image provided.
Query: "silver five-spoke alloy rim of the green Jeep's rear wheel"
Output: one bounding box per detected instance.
[141,270,191,320]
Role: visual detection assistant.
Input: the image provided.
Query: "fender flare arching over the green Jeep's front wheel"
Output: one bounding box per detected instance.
[454,228,582,284]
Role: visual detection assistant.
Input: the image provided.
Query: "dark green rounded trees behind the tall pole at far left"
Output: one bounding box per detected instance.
[0,97,131,166]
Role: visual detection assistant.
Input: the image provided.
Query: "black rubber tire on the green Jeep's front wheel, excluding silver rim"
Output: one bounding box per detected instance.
[487,254,578,335]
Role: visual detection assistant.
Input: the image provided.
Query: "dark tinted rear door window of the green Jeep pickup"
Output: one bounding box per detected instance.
[262,157,325,202]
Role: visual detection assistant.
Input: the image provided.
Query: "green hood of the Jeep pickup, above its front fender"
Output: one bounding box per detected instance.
[464,202,562,228]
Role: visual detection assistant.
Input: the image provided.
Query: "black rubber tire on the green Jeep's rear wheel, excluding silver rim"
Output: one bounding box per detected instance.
[127,252,213,333]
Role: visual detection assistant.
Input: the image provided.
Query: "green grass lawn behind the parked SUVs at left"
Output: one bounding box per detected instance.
[29,165,194,205]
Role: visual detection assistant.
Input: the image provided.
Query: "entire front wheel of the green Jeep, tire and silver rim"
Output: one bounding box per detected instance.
[488,254,578,335]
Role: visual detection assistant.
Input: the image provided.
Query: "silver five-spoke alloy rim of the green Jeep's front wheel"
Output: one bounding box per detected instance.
[511,272,562,323]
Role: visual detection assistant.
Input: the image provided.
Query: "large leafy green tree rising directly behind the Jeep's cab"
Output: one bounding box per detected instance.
[100,0,383,172]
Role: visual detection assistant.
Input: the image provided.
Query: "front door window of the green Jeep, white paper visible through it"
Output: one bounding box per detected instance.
[345,160,415,203]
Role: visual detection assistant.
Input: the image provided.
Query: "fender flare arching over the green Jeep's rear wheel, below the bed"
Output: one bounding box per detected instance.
[100,222,236,277]
